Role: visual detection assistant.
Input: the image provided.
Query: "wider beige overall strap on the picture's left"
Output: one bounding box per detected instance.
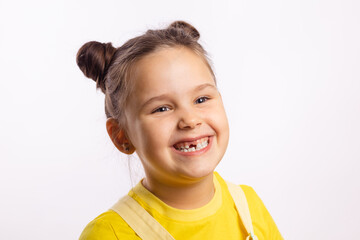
[110,195,175,240]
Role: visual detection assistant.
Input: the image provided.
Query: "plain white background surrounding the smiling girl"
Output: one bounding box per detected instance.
[0,0,360,240]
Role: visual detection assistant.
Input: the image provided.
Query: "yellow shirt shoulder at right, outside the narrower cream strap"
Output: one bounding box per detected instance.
[240,185,283,240]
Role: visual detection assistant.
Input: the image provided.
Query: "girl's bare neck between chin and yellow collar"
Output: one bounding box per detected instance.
[142,174,215,209]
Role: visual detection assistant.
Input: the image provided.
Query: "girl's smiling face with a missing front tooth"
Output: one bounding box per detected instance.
[126,47,229,184]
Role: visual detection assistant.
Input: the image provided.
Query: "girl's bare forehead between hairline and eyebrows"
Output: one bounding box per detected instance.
[132,47,215,99]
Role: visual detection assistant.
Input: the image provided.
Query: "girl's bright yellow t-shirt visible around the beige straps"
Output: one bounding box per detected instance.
[80,173,283,240]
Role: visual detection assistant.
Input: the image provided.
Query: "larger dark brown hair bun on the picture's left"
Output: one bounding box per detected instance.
[76,41,116,93]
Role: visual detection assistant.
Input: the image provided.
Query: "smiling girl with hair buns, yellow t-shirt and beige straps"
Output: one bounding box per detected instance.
[77,21,282,240]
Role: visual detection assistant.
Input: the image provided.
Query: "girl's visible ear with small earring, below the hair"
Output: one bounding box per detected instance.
[106,118,135,154]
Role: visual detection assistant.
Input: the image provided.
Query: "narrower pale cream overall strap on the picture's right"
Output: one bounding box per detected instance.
[226,181,258,240]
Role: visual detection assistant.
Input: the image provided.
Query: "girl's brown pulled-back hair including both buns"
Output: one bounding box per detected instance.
[76,21,216,127]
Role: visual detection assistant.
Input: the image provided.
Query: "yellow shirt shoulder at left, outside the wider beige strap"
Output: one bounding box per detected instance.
[79,210,139,240]
